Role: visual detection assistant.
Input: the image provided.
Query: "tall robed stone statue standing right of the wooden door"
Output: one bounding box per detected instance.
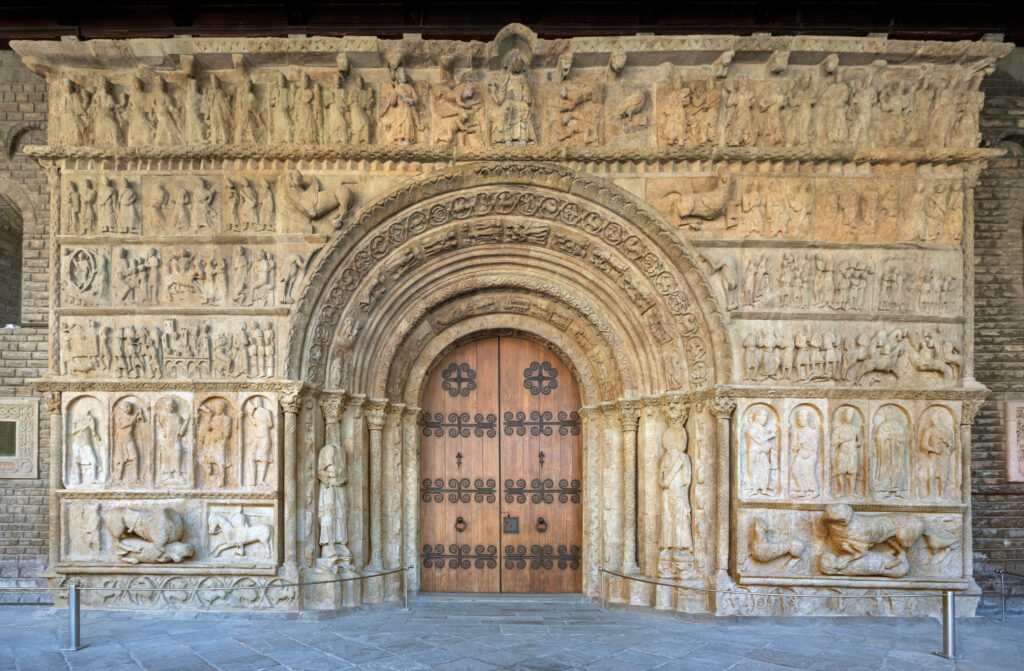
[658,404,693,577]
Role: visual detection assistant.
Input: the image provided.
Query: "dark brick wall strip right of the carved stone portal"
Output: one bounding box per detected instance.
[971,49,1024,612]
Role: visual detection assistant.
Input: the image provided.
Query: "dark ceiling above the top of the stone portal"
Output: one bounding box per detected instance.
[0,0,1024,43]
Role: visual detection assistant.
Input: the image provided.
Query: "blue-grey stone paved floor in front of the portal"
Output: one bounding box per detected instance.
[0,596,1024,671]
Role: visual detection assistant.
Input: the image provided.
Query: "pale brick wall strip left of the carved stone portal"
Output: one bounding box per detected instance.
[0,51,49,601]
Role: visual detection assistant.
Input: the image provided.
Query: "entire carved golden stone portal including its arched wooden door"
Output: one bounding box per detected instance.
[0,25,1010,615]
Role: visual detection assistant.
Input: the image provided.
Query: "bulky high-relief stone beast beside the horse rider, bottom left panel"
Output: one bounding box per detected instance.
[103,507,195,563]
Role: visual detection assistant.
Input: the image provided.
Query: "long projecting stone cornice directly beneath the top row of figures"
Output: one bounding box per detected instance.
[25,144,1004,169]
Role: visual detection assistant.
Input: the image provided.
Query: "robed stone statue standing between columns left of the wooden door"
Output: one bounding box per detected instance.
[316,443,354,574]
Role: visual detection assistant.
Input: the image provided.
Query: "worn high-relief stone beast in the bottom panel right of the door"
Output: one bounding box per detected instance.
[818,503,956,578]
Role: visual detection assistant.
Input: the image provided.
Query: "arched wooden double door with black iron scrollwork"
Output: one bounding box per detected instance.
[420,337,583,592]
